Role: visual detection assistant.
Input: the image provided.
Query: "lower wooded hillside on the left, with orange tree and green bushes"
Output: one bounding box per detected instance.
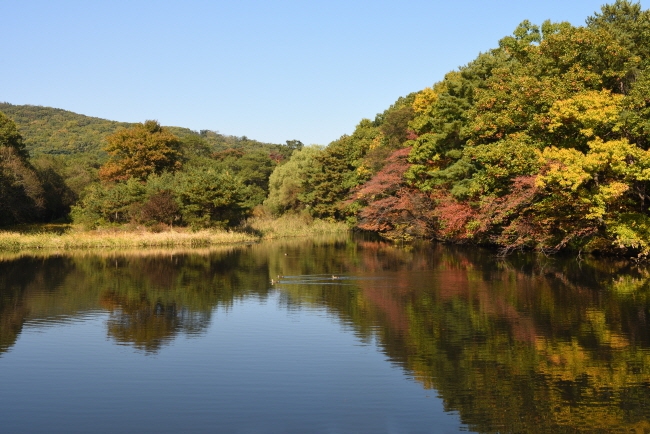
[0,103,302,227]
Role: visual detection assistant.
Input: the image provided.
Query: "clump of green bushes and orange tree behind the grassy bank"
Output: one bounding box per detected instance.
[72,121,272,228]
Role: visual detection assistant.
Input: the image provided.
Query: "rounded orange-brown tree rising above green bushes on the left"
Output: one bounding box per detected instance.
[99,120,182,181]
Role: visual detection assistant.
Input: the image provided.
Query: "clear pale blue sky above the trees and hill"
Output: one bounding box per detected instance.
[0,0,650,144]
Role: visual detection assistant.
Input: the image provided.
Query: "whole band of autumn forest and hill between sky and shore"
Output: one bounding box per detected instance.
[0,0,650,257]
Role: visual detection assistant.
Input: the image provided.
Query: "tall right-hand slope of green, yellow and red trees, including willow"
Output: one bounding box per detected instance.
[268,1,650,256]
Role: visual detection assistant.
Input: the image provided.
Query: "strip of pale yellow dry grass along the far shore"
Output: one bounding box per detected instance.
[0,216,348,251]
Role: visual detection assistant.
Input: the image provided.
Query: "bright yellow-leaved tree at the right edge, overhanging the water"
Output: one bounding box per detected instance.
[536,138,650,256]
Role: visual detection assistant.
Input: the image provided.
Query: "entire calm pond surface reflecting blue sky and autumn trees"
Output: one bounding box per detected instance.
[0,238,650,433]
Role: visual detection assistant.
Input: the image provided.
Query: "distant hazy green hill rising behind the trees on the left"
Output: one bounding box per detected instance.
[0,102,284,156]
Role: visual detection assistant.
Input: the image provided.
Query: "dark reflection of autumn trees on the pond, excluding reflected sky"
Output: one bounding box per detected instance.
[0,239,650,432]
